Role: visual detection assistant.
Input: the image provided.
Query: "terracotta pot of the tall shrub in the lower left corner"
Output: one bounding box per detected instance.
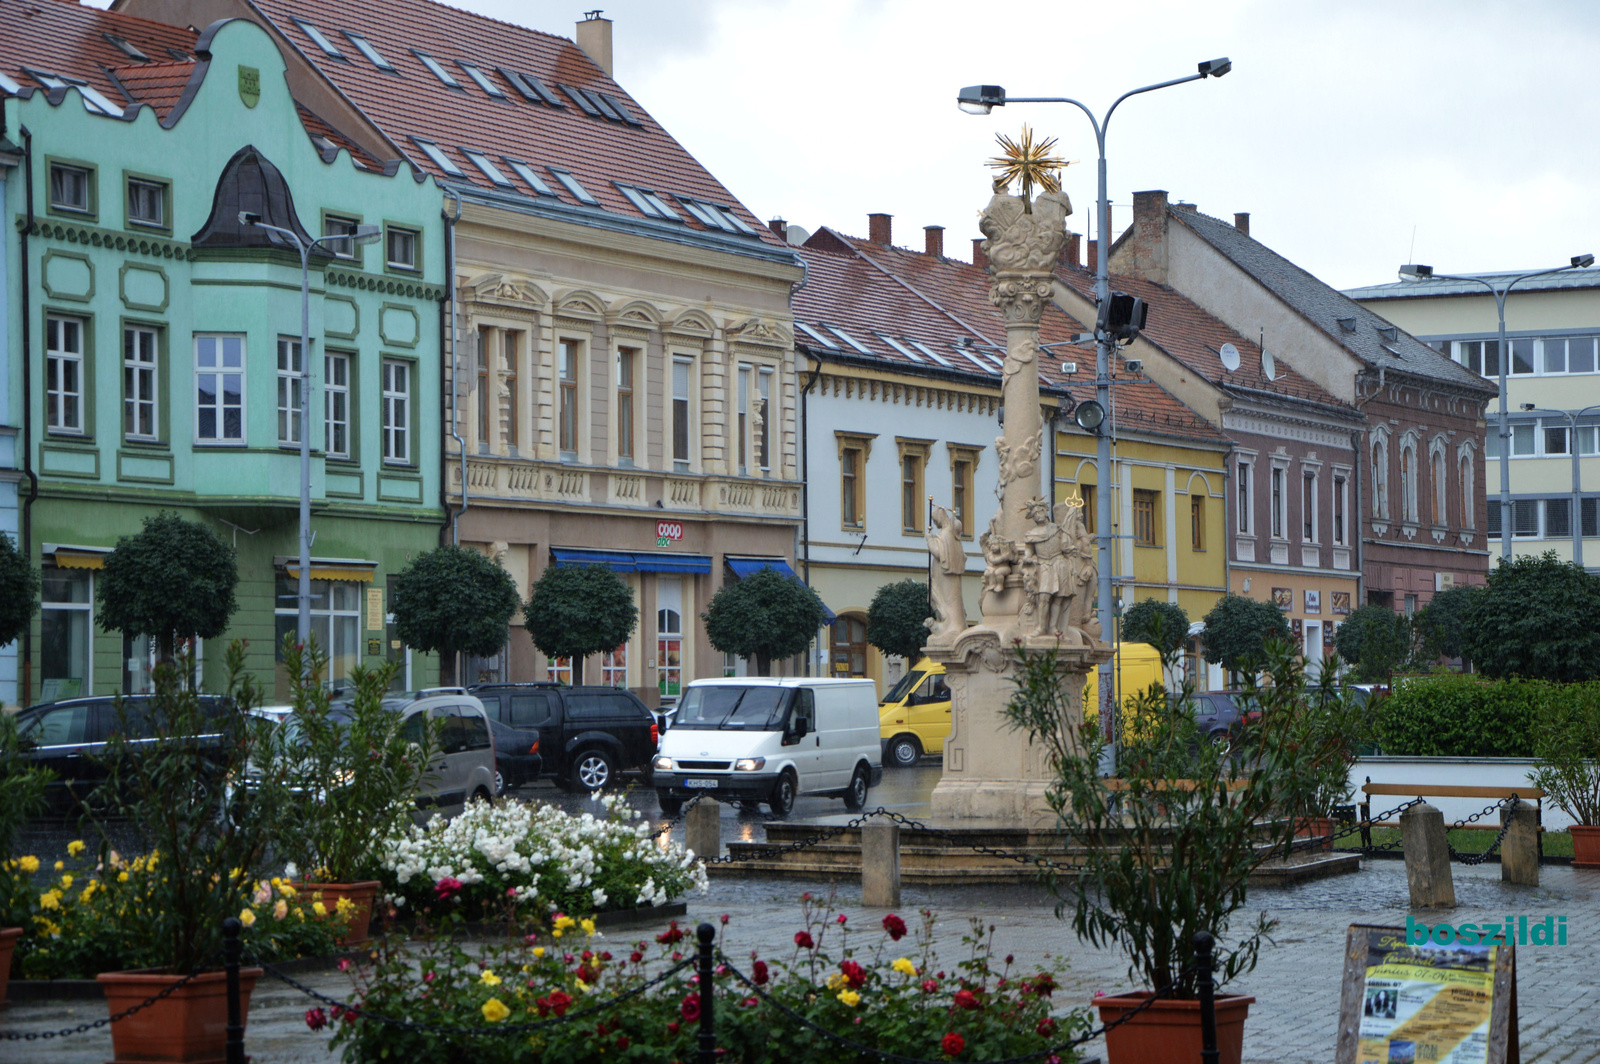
[98,968,261,1064]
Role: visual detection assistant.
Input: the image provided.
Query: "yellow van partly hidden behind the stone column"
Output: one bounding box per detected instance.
[878,643,1162,768]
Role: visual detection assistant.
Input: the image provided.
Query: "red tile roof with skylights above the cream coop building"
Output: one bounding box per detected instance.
[244,0,782,245]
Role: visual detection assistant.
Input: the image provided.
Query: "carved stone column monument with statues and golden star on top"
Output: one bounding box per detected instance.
[923,153,1112,827]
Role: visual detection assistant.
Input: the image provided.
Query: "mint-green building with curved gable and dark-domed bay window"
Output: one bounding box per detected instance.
[0,12,445,704]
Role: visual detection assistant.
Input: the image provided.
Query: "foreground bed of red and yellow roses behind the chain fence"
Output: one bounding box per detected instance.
[323,896,1090,1064]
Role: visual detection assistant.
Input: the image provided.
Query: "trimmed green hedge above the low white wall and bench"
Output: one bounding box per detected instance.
[1378,674,1600,757]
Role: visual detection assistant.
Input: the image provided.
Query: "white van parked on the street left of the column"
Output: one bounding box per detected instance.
[653,677,883,816]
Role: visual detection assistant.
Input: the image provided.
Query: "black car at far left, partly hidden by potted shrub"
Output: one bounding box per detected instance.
[16,694,227,813]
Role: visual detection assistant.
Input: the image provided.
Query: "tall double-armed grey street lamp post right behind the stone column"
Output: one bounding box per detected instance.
[957,59,1234,764]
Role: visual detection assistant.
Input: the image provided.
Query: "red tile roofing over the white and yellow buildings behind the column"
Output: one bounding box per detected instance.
[794,227,1226,443]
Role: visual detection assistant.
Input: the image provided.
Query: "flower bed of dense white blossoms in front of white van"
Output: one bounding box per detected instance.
[381,795,706,918]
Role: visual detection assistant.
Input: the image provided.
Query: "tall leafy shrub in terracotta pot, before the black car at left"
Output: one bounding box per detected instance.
[94,642,290,1061]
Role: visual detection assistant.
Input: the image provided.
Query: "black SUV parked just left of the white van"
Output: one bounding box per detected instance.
[469,683,661,790]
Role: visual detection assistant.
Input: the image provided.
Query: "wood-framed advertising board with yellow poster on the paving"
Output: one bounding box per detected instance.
[1334,923,1520,1064]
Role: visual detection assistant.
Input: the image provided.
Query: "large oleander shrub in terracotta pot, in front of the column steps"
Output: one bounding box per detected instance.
[1006,642,1349,1064]
